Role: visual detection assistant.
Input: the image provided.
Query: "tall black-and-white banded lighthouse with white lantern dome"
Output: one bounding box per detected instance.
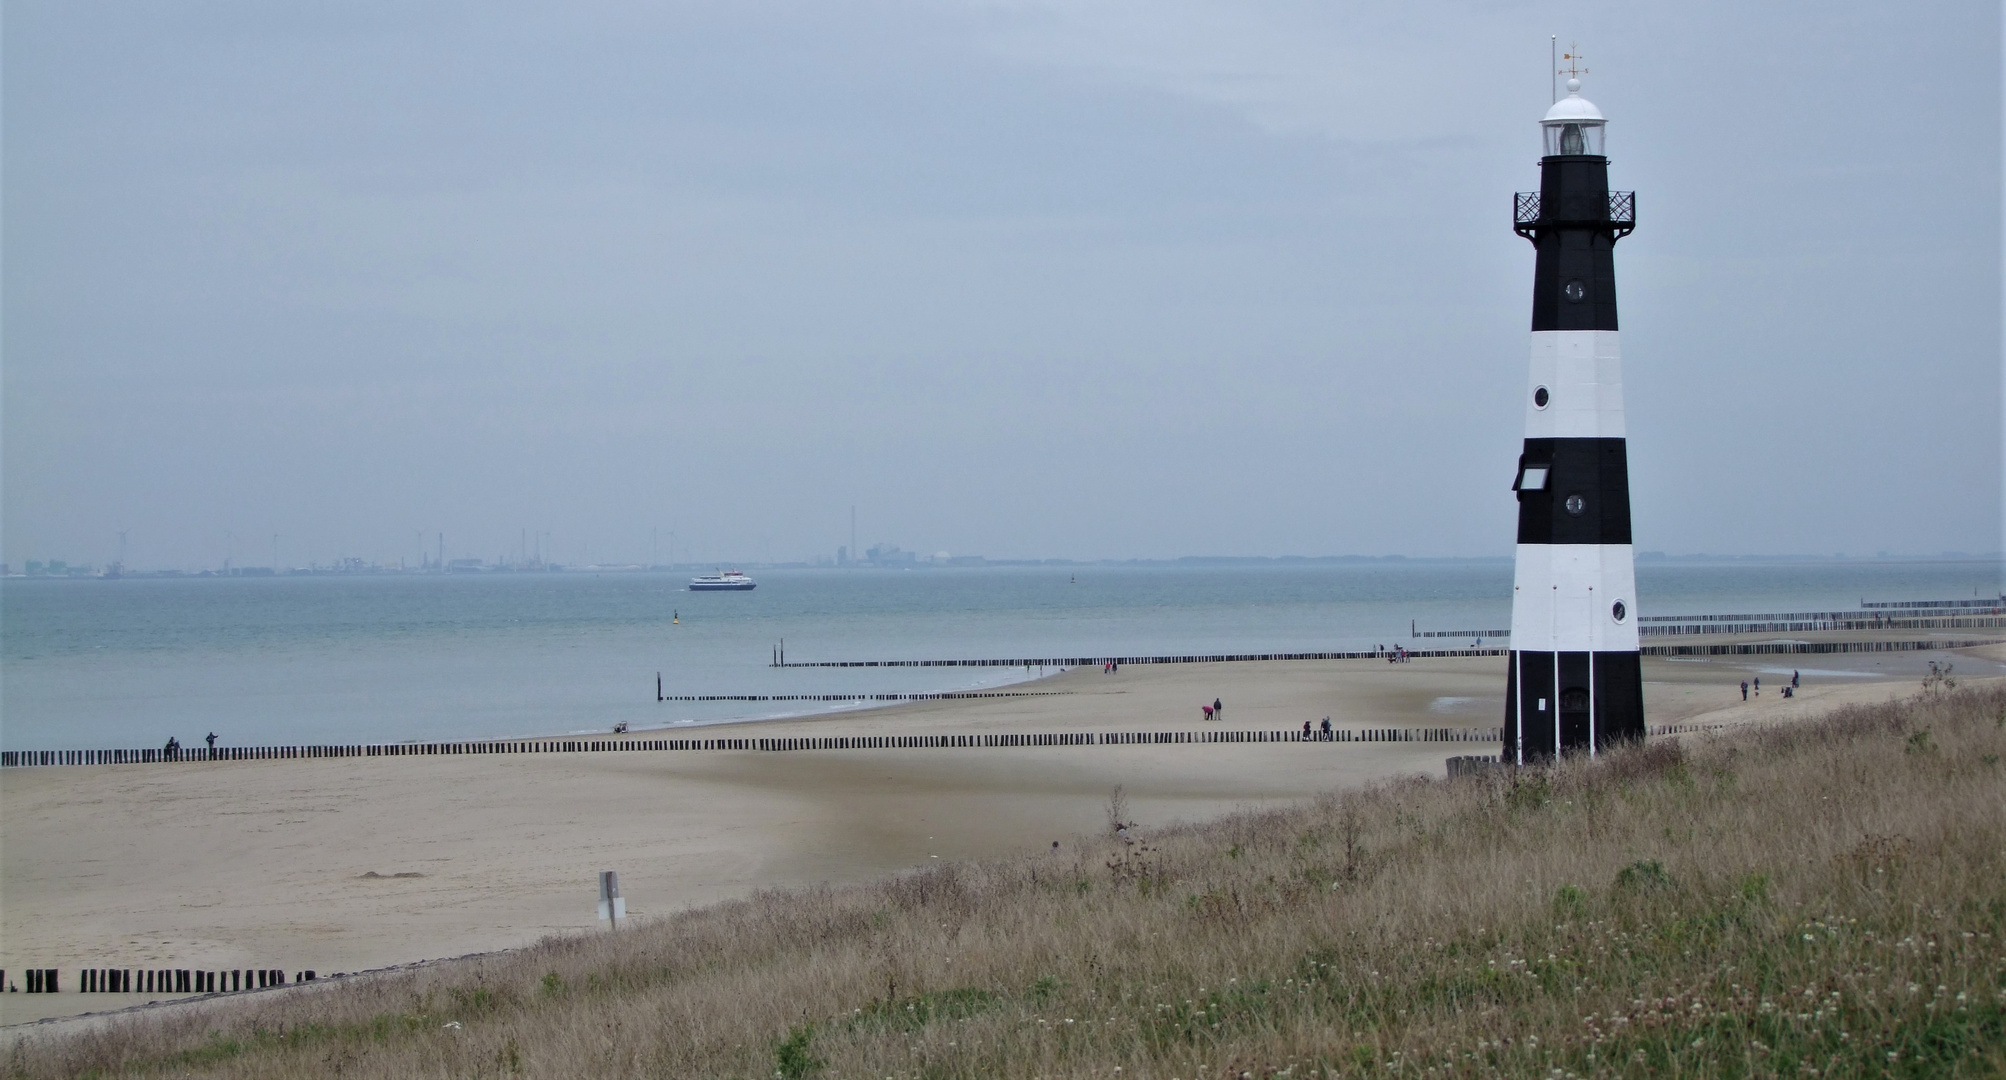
[1505,78,1643,765]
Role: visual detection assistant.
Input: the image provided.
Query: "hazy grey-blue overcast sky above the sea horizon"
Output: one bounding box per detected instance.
[0,0,2002,568]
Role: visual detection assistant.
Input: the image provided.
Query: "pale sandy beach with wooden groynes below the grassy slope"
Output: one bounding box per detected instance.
[0,646,2006,1024]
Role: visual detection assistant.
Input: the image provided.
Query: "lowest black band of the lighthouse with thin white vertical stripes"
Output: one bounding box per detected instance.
[1505,650,1643,765]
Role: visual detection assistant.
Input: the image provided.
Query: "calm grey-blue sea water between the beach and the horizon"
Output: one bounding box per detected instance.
[0,560,2000,749]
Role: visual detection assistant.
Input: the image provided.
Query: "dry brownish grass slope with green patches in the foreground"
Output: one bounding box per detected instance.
[6,685,2006,1080]
